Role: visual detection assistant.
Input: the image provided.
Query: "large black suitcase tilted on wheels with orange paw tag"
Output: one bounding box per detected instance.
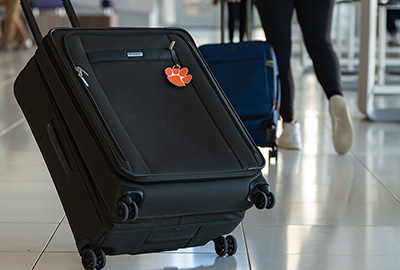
[14,0,275,269]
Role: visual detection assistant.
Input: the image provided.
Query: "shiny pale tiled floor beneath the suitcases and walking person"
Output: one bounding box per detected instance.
[0,28,400,270]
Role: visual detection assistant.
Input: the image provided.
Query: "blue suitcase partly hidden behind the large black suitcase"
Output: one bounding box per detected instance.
[199,41,280,158]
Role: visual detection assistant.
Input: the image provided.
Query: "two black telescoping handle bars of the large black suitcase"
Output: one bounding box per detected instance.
[21,0,80,45]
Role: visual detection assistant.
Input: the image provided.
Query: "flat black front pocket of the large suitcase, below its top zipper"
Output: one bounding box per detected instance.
[87,59,242,174]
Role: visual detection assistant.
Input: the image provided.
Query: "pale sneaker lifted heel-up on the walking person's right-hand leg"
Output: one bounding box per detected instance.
[329,95,353,155]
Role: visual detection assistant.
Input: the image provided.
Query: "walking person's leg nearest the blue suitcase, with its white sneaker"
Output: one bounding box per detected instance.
[254,0,301,149]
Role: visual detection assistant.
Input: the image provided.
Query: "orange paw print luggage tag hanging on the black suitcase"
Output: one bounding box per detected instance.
[164,41,193,87]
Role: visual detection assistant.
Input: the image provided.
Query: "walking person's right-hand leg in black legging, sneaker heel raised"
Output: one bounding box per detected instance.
[295,0,353,154]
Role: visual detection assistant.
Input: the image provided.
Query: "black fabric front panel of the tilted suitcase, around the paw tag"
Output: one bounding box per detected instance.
[45,30,263,178]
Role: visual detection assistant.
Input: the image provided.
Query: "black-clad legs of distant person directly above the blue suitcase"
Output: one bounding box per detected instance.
[228,0,247,42]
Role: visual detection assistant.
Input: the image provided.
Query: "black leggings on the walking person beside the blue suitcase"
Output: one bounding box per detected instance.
[254,0,342,122]
